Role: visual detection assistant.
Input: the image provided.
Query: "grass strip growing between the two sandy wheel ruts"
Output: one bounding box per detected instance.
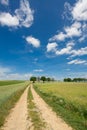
[28,87,45,130]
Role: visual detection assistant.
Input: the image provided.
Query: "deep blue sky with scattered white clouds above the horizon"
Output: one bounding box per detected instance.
[0,0,87,80]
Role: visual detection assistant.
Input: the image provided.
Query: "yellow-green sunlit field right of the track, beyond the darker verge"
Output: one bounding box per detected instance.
[36,82,87,105]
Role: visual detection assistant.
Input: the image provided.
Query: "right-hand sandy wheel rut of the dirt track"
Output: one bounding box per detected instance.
[31,86,72,130]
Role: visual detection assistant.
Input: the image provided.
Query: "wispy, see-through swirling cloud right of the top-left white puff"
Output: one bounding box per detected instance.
[15,0,34,27]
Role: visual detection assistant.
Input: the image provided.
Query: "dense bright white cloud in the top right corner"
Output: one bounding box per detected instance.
[71,0,87,21]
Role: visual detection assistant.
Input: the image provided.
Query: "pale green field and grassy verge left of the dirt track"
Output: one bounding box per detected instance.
[0,82,29,127]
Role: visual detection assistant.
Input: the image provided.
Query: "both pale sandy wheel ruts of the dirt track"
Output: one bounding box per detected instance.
[2,85,72,130]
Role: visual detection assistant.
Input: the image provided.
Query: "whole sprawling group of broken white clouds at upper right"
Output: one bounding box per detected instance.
[47,0,87,57]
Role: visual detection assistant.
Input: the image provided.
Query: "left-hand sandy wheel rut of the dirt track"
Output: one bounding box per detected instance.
[2,88,29,130]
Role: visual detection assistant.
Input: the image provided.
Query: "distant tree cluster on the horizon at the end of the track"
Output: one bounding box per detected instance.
[30,76,55,83]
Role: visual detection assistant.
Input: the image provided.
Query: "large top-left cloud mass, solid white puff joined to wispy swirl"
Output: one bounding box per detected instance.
[0,0,34,28]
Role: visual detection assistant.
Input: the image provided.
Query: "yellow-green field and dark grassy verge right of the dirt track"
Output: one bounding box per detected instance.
[34,83,87,130]
